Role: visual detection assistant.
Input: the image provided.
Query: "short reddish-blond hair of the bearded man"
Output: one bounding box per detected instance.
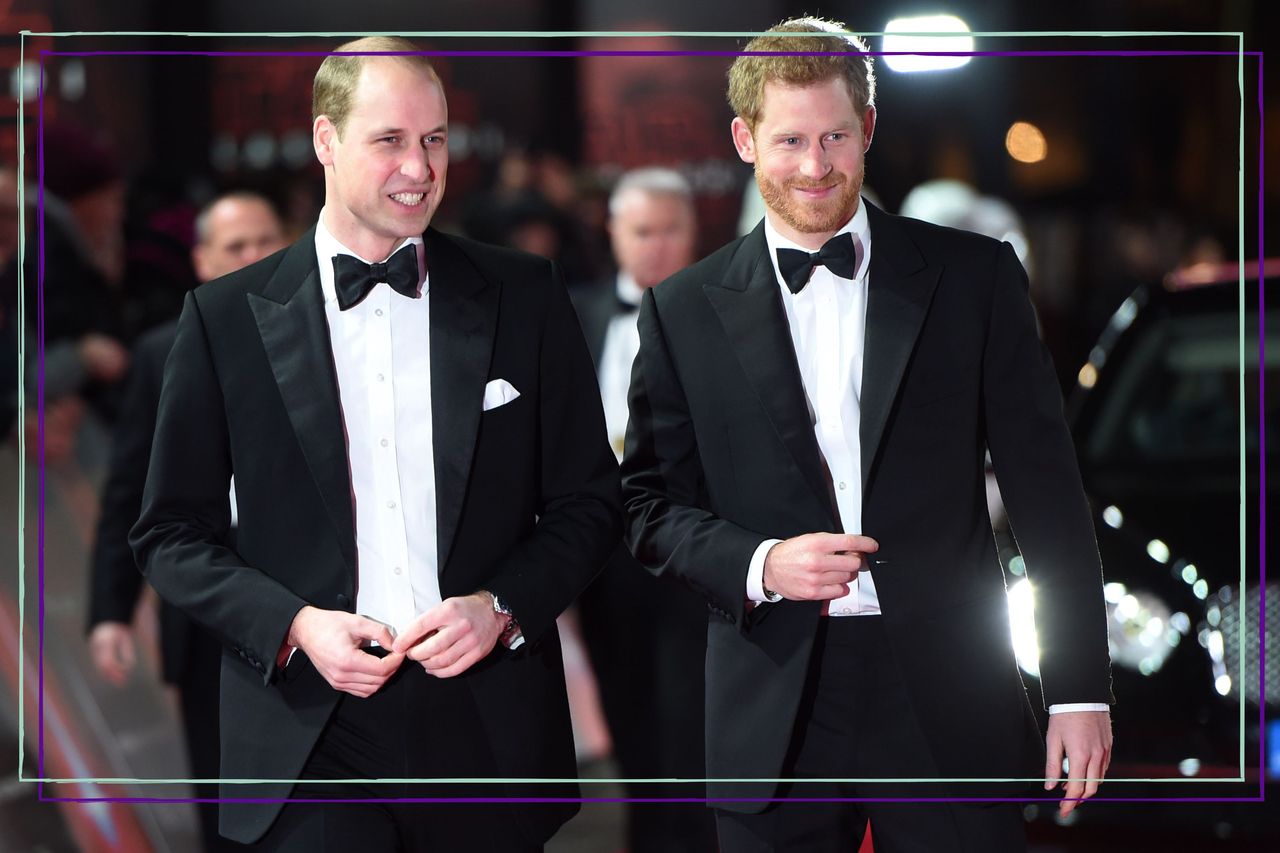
[728,18,876,131]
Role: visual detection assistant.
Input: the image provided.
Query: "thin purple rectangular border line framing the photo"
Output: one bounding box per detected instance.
[36,44,1267,803]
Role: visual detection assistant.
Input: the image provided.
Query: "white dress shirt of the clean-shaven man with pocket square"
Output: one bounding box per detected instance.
[316,211,440,634]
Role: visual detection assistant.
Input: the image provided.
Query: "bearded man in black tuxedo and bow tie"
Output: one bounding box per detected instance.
[623,19,1111,852]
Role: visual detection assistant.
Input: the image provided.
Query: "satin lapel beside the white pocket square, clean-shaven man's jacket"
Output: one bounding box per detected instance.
[425,229,502,571]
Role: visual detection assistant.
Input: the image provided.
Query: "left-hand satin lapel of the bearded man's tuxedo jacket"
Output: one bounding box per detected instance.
[703,222,836,530]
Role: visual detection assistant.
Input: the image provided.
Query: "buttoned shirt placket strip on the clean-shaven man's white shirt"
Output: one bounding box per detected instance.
[365,284,416,629]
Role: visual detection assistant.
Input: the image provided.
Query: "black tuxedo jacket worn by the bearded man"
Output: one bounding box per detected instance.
[622,205,1111,811]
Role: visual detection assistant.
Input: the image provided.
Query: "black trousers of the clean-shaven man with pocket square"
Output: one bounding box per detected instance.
[251,661,541,853]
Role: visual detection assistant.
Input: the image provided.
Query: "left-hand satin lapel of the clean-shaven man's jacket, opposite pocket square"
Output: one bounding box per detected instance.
[248,229,356,571]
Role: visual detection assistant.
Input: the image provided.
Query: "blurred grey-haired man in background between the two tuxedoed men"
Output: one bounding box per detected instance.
[575,168,716,853]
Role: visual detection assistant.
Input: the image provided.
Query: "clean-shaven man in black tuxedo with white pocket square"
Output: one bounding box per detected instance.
[132,37,620,853]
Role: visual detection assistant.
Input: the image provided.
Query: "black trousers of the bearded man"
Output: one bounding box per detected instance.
[716,616,1027,853]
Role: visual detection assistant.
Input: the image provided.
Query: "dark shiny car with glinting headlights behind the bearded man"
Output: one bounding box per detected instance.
[1009,261,1280,849]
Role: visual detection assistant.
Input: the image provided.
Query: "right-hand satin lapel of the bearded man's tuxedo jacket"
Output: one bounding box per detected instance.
[859,201,942,496]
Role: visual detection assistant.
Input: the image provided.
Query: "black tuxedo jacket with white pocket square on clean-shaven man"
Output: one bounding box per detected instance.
[132,229,621,841]
